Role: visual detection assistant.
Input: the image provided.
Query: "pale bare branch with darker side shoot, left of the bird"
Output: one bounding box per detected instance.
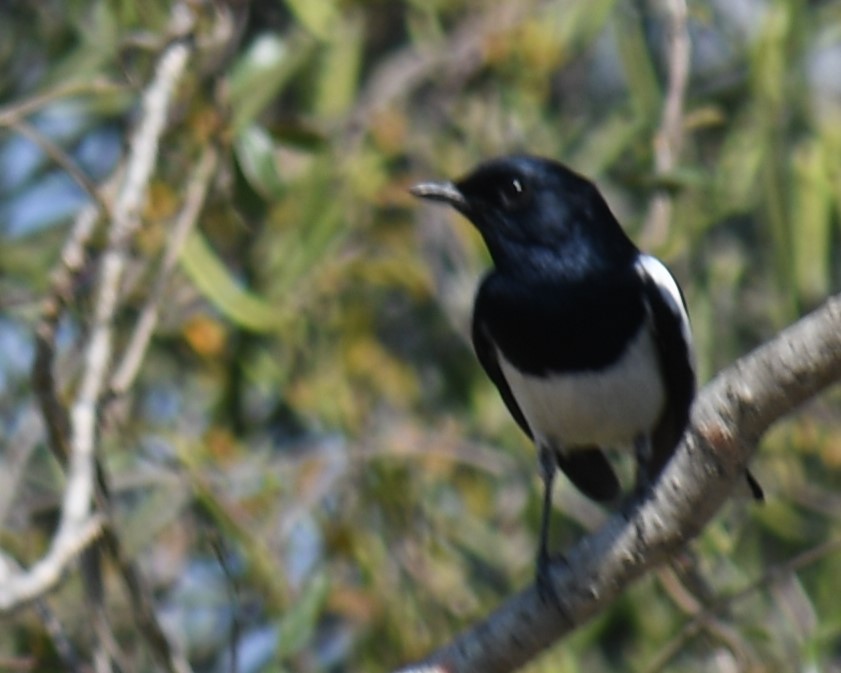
[0,26,191,672]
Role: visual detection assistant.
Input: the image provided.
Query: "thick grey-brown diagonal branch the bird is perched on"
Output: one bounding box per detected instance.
[403,295,841,673]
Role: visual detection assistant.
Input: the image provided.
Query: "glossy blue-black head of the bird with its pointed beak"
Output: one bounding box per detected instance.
[411,155,636,270]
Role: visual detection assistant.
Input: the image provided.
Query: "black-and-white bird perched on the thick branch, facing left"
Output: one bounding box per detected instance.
[410,154,762,598]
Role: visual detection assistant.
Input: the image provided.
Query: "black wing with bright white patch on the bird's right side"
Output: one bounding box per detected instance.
[637,255,695,477]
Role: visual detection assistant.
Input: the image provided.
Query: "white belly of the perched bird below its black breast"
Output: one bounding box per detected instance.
[498,325,664,449]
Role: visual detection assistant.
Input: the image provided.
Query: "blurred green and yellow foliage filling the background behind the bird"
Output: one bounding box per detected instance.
[0,0,841,673]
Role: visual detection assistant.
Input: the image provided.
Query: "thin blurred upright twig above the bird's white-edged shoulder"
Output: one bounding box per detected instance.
[641,0,691,248]
